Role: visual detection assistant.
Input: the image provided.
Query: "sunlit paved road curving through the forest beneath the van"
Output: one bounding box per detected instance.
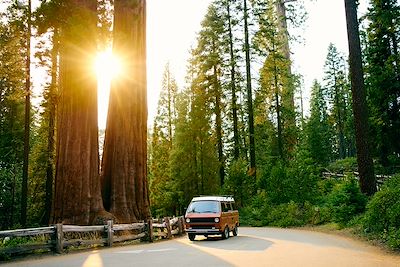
[0,227,400,267]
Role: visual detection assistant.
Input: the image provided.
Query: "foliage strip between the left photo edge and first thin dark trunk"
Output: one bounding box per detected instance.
[0,12,25,229]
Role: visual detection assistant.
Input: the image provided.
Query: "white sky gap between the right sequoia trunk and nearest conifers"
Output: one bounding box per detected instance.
[147,0,211,124]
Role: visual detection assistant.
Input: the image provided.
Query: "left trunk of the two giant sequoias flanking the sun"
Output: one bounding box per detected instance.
[52,0,104,224]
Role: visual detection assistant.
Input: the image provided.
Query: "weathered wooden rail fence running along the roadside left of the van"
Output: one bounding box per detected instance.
[0,217,185,258]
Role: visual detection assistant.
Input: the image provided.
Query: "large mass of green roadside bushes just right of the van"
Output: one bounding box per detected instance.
[241,151,321,227]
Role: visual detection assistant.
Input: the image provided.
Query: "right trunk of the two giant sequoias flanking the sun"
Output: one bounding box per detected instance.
[102,0,150,223]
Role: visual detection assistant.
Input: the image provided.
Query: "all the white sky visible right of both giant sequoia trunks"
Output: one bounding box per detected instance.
[143,0,367,124]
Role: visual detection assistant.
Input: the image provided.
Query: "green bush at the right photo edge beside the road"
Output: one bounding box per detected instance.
[363,175,400,249]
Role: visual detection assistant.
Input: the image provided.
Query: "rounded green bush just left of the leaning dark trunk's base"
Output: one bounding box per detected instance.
[327,179,367,226]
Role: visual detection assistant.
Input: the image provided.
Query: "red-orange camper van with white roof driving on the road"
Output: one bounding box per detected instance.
[185,196,239,241]
